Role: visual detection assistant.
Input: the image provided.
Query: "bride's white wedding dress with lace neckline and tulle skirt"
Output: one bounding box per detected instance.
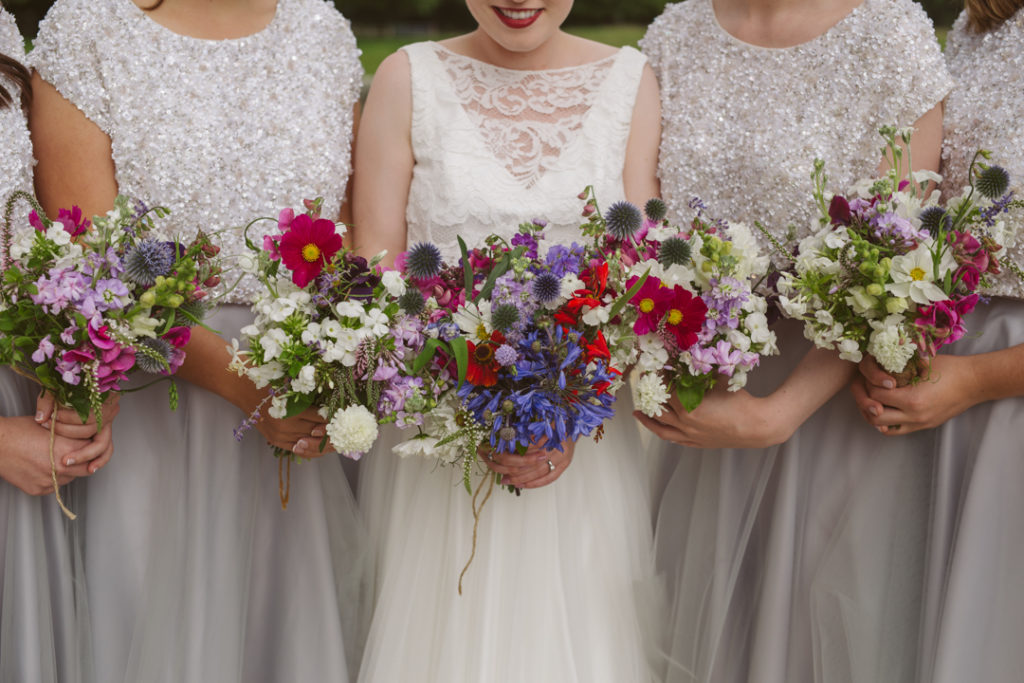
[359,42,653,683]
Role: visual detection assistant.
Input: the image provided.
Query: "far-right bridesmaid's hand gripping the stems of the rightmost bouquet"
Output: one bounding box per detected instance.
[850,355,984,435]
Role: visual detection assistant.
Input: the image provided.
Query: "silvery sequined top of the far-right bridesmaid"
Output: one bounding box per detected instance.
[942,10,1024,299]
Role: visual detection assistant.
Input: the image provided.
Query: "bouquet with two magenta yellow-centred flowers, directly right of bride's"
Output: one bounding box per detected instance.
[595,193,778,417]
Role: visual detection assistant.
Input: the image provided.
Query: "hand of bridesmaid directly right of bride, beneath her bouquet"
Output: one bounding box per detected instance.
[633,384,798,449]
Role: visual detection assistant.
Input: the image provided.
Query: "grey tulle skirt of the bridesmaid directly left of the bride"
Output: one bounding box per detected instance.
[80,306,365,683]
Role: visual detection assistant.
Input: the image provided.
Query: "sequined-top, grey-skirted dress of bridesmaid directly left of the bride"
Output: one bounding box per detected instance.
[33,0,362,683]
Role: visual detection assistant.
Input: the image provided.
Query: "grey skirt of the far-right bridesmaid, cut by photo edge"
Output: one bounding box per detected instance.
[920,299,1024,683]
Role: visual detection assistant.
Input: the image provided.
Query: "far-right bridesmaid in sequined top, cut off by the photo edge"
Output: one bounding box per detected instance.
[855,0,1024,683]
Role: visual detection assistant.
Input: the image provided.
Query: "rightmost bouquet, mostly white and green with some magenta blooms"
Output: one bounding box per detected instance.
[778,128,1012,385]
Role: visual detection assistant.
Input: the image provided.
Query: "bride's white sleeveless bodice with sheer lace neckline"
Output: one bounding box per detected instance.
[402,42,645,258]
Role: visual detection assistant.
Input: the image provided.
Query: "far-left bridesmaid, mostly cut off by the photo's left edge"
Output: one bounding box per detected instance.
[0,6,116,683]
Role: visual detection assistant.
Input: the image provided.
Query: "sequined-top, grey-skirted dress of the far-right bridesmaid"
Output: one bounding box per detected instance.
[921,10,1024,683]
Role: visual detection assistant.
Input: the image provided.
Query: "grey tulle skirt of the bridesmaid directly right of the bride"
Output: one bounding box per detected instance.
[656,321,933,683]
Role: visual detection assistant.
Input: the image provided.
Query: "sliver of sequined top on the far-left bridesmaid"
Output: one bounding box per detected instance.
[0,7,33,201]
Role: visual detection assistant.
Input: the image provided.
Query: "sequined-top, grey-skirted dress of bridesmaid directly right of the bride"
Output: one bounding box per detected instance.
[641,0,950,683]
